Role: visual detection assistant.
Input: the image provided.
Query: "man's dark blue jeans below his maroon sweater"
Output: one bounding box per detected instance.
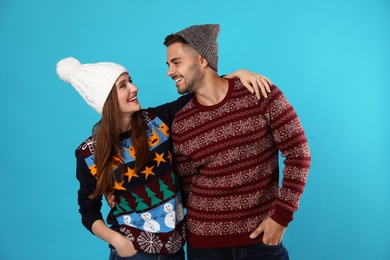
[187,242,289,260]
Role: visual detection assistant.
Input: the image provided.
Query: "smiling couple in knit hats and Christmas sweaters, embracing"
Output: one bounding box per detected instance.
[57,24,310,259]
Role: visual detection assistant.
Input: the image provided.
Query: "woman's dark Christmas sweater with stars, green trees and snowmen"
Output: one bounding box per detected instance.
[75,95,192,254]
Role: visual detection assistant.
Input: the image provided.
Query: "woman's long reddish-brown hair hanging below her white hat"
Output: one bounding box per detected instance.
[89,81,151,199]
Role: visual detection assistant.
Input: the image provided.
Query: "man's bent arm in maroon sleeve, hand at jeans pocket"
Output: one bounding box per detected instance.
[250,87,311,245]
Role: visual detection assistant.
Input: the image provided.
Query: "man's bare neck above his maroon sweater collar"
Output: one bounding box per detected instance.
[194,72,229,106]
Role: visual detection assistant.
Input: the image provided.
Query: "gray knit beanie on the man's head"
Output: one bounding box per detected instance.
[176,24,219,71]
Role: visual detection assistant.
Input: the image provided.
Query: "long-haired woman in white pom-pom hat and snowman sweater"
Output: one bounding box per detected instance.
[57,58,268,259]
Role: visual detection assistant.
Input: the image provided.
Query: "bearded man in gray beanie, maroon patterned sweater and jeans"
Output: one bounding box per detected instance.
[164,24,311,260]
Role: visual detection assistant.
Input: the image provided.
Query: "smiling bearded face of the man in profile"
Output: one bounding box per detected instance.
[166,43,202,94]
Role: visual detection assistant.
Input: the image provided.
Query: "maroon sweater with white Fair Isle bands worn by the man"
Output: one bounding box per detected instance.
[172,79,311,248]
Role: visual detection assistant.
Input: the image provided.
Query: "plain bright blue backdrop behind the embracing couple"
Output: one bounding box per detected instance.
[0,0,390,260]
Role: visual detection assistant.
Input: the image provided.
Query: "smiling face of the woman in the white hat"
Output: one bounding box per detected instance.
[115,73,141,115]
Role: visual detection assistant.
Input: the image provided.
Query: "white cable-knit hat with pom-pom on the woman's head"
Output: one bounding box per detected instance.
[57,57,127,114]
